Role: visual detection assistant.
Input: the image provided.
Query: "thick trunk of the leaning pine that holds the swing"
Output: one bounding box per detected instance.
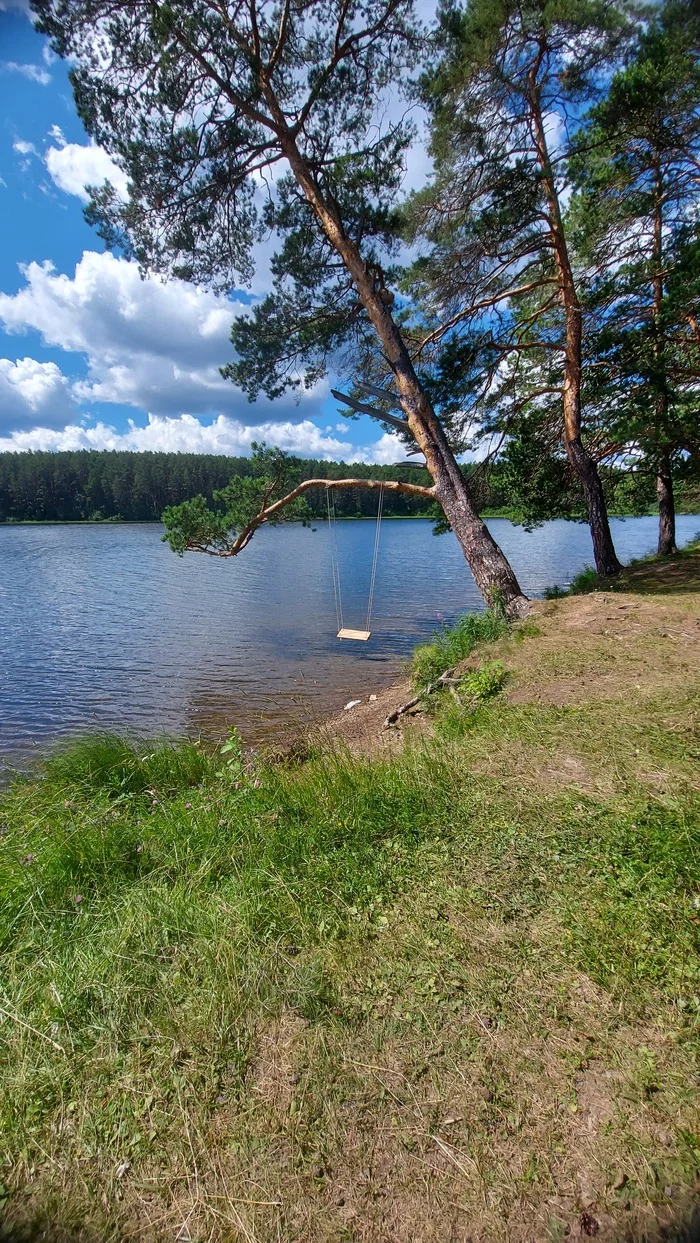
[279,131,527,617]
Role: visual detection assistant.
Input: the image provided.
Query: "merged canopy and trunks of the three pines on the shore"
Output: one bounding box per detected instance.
[32,0,700,591]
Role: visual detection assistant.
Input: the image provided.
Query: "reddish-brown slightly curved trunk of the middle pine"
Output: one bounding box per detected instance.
[531,86,622,578]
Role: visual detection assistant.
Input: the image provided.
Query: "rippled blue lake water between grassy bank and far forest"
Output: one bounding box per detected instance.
[0,516,700,759]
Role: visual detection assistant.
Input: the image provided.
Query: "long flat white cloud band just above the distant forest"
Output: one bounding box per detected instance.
[0,415,362,461]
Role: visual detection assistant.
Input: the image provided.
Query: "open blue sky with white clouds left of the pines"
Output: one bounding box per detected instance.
[0,0,415,462]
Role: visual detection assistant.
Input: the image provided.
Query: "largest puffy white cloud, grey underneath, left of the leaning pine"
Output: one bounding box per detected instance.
[0,251,325,421]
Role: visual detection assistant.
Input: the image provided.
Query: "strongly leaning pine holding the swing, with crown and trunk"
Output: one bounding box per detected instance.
[32,0,523,612]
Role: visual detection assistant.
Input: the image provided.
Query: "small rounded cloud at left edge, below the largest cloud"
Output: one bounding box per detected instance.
[0,358,75,428]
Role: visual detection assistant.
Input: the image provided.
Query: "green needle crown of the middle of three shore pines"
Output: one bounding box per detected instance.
[404,0,635,479]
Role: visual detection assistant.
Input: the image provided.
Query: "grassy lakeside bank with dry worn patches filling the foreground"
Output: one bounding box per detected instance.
[0,553,700,1243]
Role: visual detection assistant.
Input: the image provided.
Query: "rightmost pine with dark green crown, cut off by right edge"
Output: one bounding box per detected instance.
[571,0,700,553]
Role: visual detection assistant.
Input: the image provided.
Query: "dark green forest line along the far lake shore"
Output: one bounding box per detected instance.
[0,450,700,522]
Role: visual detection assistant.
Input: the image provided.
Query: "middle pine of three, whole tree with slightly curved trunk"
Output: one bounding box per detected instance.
[412,0,630,574]
